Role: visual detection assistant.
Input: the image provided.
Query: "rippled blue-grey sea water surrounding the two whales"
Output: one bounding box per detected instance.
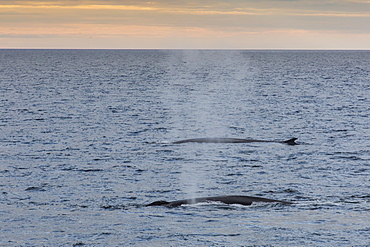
[0,50,370,246]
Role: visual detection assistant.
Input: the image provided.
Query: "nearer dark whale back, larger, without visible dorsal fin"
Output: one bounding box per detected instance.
[146,196,293,208]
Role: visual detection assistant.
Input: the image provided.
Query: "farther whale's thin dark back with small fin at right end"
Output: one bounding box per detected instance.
[172,138,298,145]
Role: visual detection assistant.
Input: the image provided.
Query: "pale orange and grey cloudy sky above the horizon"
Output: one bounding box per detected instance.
[0,0,370,50]
